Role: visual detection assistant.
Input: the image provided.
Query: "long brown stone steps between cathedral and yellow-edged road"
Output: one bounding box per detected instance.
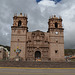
[0,61,75,68]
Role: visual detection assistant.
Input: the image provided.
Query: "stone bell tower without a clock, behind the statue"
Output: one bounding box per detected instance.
[10,13,28,60]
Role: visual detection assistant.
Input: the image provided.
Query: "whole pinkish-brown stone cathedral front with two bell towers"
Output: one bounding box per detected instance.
[10,13,64,62]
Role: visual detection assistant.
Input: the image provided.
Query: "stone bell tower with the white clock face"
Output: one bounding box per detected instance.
[48,15,64,62]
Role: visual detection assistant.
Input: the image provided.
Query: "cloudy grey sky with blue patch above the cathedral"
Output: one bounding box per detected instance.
[0,0,75,49]
